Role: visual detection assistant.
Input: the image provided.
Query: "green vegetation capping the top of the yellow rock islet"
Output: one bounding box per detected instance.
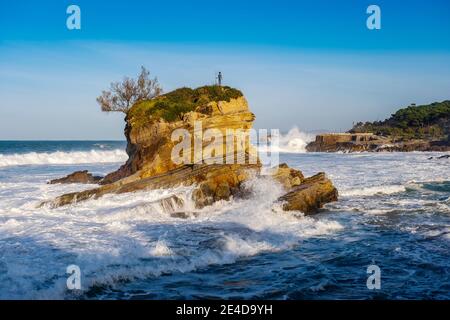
[127,86,242,126]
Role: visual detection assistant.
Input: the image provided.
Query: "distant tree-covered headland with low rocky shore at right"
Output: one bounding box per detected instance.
[306,100,450,152]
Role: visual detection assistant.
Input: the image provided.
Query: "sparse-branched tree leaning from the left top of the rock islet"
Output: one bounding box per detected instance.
[97,67,163,113]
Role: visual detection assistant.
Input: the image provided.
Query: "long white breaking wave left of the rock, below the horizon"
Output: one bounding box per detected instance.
[0,149,128,167]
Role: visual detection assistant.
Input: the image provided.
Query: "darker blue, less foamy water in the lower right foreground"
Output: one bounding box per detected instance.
[88,189,450,300]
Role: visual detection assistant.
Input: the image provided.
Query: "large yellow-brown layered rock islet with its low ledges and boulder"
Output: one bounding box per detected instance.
[42,86,338,216]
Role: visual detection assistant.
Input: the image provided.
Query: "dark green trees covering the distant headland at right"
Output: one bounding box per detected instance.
[350,100,450,140]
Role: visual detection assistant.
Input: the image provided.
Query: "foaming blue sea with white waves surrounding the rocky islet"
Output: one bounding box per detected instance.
[0,129,450,300]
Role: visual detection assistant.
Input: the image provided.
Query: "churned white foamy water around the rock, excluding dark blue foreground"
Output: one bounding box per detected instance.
[0,145,450,299]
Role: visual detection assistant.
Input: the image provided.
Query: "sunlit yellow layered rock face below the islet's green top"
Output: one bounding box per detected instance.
[103,97,255,183]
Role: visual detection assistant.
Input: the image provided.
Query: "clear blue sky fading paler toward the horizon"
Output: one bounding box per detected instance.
[0,0,450,139]
